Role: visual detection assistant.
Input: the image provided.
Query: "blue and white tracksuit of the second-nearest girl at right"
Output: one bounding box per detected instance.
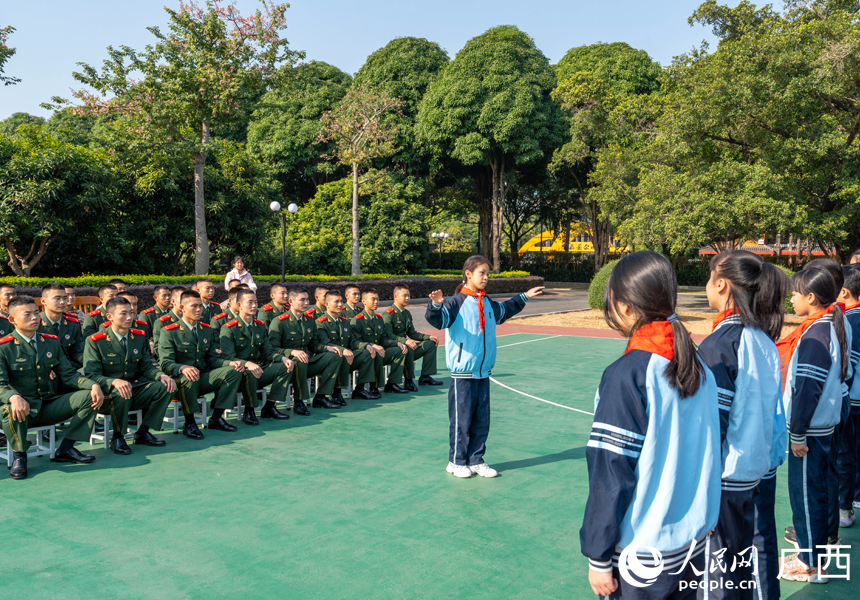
[699,315,787,599]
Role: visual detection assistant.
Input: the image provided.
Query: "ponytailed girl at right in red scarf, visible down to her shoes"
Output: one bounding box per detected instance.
[777,266,849,583]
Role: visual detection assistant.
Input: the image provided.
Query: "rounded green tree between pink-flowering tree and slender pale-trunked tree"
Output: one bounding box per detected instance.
[248,61,351,204]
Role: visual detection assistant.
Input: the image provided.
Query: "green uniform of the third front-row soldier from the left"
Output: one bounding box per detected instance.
[158,321,242,414]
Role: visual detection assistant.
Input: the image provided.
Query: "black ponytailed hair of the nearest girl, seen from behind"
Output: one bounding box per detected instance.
[603,250,705,398]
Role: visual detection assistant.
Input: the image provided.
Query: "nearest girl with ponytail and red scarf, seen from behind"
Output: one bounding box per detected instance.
[579,251,721,598]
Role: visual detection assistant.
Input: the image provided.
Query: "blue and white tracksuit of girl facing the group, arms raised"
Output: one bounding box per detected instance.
[425,292,528,465]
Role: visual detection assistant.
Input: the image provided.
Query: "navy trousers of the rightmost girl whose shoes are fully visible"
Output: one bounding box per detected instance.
[788,434,833,567]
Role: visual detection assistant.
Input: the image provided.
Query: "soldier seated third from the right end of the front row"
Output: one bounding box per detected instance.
[312,290,372,408]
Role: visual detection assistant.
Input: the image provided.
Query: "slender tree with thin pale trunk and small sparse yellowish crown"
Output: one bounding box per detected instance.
[318,85,403,275]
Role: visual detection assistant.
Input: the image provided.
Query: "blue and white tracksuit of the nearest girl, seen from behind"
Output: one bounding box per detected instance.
[579,350,721,598]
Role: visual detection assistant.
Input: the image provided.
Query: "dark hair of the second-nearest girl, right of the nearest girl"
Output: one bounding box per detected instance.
[710,250,790,341]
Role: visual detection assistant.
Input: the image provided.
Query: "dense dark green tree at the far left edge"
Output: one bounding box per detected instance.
[0,126,114,277]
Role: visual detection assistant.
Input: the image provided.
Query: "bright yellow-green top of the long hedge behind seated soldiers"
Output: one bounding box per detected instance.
[0,271,529,287]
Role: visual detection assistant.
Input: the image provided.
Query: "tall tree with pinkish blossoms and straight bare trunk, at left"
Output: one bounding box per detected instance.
[54,0,303,274]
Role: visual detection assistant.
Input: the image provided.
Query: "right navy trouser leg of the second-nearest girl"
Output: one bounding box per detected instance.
[753,473,779,600]
